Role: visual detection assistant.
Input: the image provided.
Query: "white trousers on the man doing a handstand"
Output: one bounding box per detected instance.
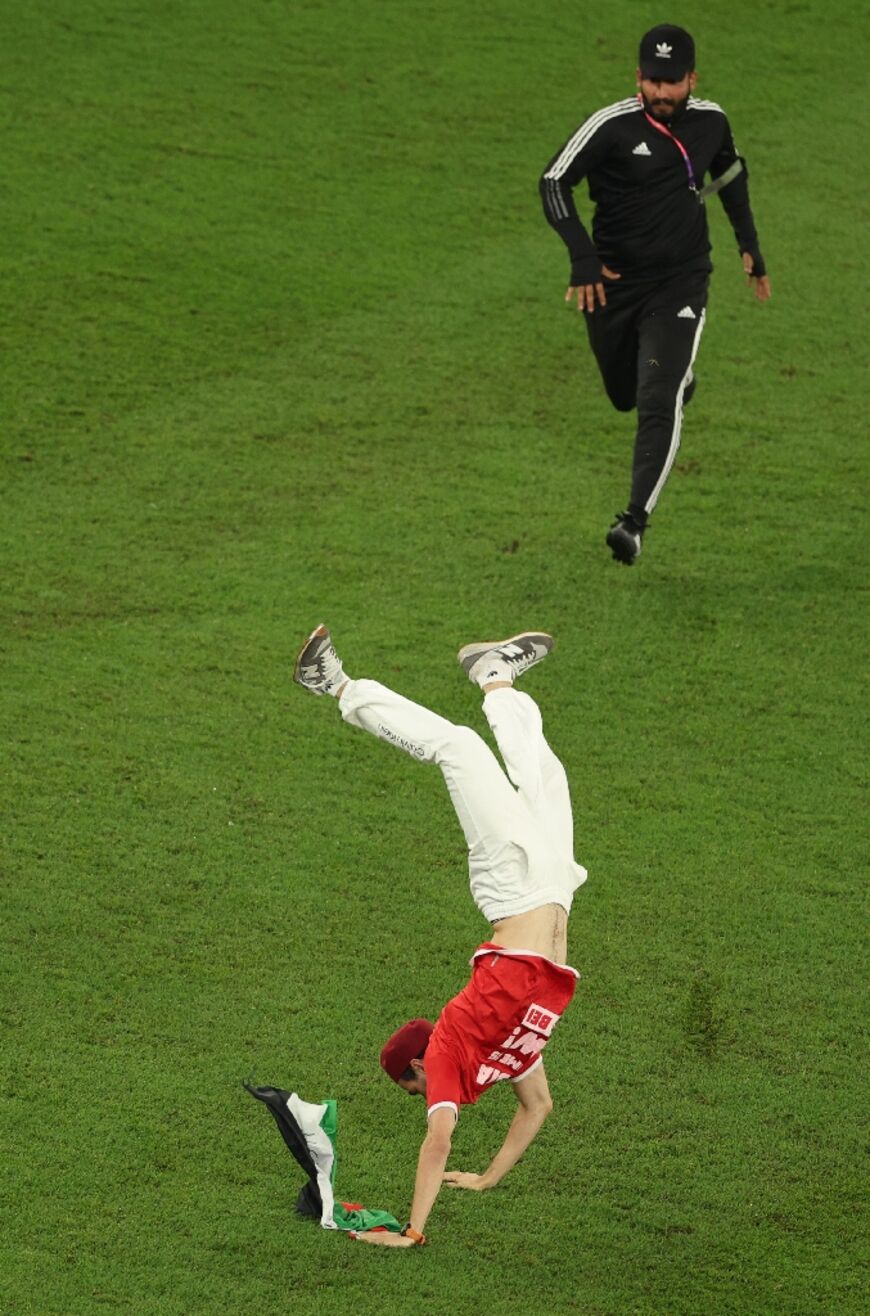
[335,680,586,923]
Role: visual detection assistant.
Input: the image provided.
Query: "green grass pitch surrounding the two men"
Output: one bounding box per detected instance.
[0,0,870,1316]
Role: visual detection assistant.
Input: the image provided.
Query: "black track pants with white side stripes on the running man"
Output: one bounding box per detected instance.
[584,272,709,516]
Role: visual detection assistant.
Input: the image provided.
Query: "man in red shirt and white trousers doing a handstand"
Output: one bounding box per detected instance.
[294,625,586,1246]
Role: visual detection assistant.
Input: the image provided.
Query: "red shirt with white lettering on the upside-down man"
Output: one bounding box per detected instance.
[425,942,579,1115]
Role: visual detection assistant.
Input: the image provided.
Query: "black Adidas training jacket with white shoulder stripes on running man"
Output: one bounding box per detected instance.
[541,96,765,287]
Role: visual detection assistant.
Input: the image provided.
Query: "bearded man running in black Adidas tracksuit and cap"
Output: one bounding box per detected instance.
[541,25,770,566]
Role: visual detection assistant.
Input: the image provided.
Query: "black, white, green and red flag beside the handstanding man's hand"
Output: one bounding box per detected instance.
[243,1083,401,1233]
